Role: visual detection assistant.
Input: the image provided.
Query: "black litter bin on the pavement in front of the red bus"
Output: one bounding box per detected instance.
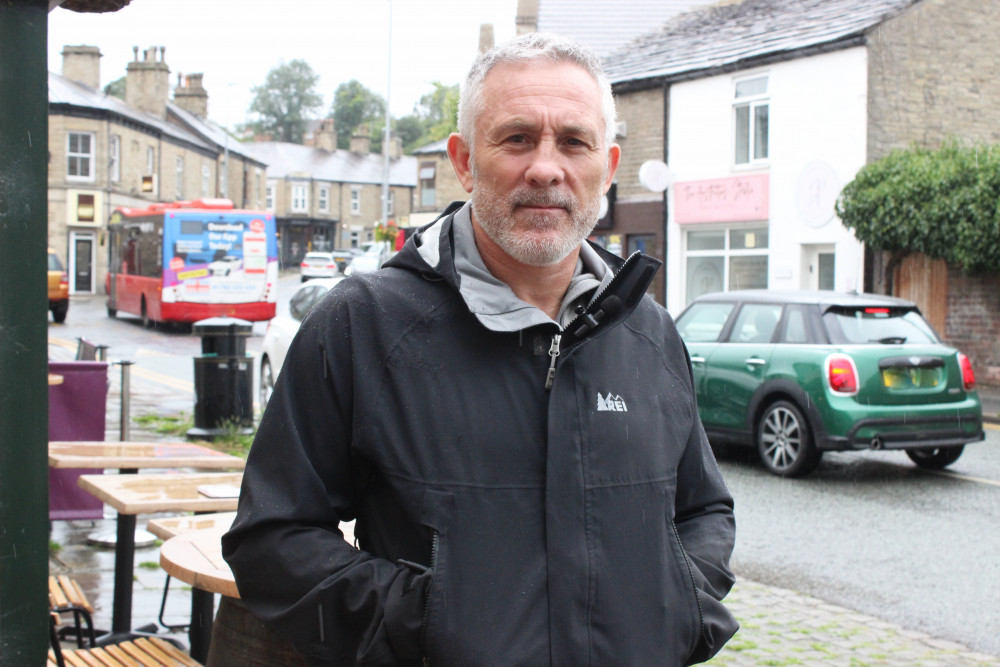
[187,317,253,440]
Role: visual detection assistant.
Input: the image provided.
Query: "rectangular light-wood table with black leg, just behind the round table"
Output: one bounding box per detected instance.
[78,472,243,651]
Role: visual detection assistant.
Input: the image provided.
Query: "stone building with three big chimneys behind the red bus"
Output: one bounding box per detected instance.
[47,45,267,294]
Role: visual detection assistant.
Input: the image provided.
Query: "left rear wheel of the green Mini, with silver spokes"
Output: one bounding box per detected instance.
[757,401,823,477]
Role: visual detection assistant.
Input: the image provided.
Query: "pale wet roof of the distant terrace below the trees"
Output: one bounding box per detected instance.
[247,141,417,188]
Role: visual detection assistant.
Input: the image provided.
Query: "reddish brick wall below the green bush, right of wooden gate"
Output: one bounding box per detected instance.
[944,267,1000,388]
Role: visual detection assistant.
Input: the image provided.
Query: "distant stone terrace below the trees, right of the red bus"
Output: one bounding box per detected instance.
[247,128,417,266]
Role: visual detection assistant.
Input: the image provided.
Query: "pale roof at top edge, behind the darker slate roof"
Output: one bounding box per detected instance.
[538,0,718,57]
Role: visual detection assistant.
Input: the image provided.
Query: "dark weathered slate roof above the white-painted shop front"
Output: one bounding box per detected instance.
[603,0,921,88]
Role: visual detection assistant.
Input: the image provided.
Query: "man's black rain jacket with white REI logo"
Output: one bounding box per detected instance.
[229,209,737,667]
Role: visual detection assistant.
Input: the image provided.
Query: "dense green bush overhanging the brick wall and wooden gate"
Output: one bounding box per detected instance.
[836,141,1000,276]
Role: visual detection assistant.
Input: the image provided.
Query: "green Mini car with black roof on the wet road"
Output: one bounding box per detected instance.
[677,290,983,477]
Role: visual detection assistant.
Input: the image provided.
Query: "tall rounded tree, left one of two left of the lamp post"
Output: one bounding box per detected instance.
[248,60,323,144]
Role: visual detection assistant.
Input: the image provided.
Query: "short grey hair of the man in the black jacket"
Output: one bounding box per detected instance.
[458,32,615,151]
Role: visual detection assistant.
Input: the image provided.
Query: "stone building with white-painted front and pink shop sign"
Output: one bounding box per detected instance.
[600,0,1000,383]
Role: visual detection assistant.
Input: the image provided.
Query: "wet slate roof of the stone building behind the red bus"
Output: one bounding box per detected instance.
[49,72,259,161]
